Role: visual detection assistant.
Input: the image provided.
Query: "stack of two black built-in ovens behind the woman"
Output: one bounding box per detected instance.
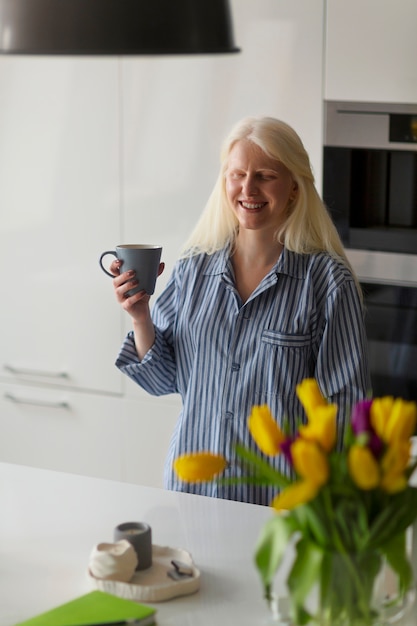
[323,101,417,400]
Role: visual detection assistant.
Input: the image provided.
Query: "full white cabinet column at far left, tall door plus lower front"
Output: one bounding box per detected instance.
[0,57,123,479]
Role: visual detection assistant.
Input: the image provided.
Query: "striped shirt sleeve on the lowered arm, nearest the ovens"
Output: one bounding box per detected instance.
[315,280,371,442]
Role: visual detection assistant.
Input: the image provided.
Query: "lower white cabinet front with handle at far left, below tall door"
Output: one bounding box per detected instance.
[0,383,123,480]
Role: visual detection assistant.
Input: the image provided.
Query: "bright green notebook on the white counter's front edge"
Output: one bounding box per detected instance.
[15,591,156,626]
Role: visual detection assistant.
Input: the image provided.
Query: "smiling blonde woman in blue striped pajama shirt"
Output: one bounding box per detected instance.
[113,118,369,504]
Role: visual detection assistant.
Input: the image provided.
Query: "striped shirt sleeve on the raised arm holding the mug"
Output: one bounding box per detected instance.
[116,269,178,396]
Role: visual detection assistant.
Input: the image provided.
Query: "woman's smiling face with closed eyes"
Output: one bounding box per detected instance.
[226,139,297,233]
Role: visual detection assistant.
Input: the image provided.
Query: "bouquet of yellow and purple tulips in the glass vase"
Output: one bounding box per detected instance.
[174,379,417,626]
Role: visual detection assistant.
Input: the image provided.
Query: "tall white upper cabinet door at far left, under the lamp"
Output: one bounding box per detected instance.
[0,57,122,393]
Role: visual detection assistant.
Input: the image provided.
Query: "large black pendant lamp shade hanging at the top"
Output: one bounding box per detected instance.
[0,0,239,55]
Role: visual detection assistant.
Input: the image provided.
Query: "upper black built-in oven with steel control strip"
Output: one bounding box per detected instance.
[323,101,417,254]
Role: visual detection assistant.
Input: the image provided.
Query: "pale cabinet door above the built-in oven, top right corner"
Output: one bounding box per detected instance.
[325,0,417,103]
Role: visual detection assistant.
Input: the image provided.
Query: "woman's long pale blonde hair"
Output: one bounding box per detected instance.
[182,117,352,269]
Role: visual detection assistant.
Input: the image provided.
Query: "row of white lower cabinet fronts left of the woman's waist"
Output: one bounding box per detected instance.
[0,376,180,487]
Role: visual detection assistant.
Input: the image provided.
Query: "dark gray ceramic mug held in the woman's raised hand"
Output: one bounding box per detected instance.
[99,244,162,296]
